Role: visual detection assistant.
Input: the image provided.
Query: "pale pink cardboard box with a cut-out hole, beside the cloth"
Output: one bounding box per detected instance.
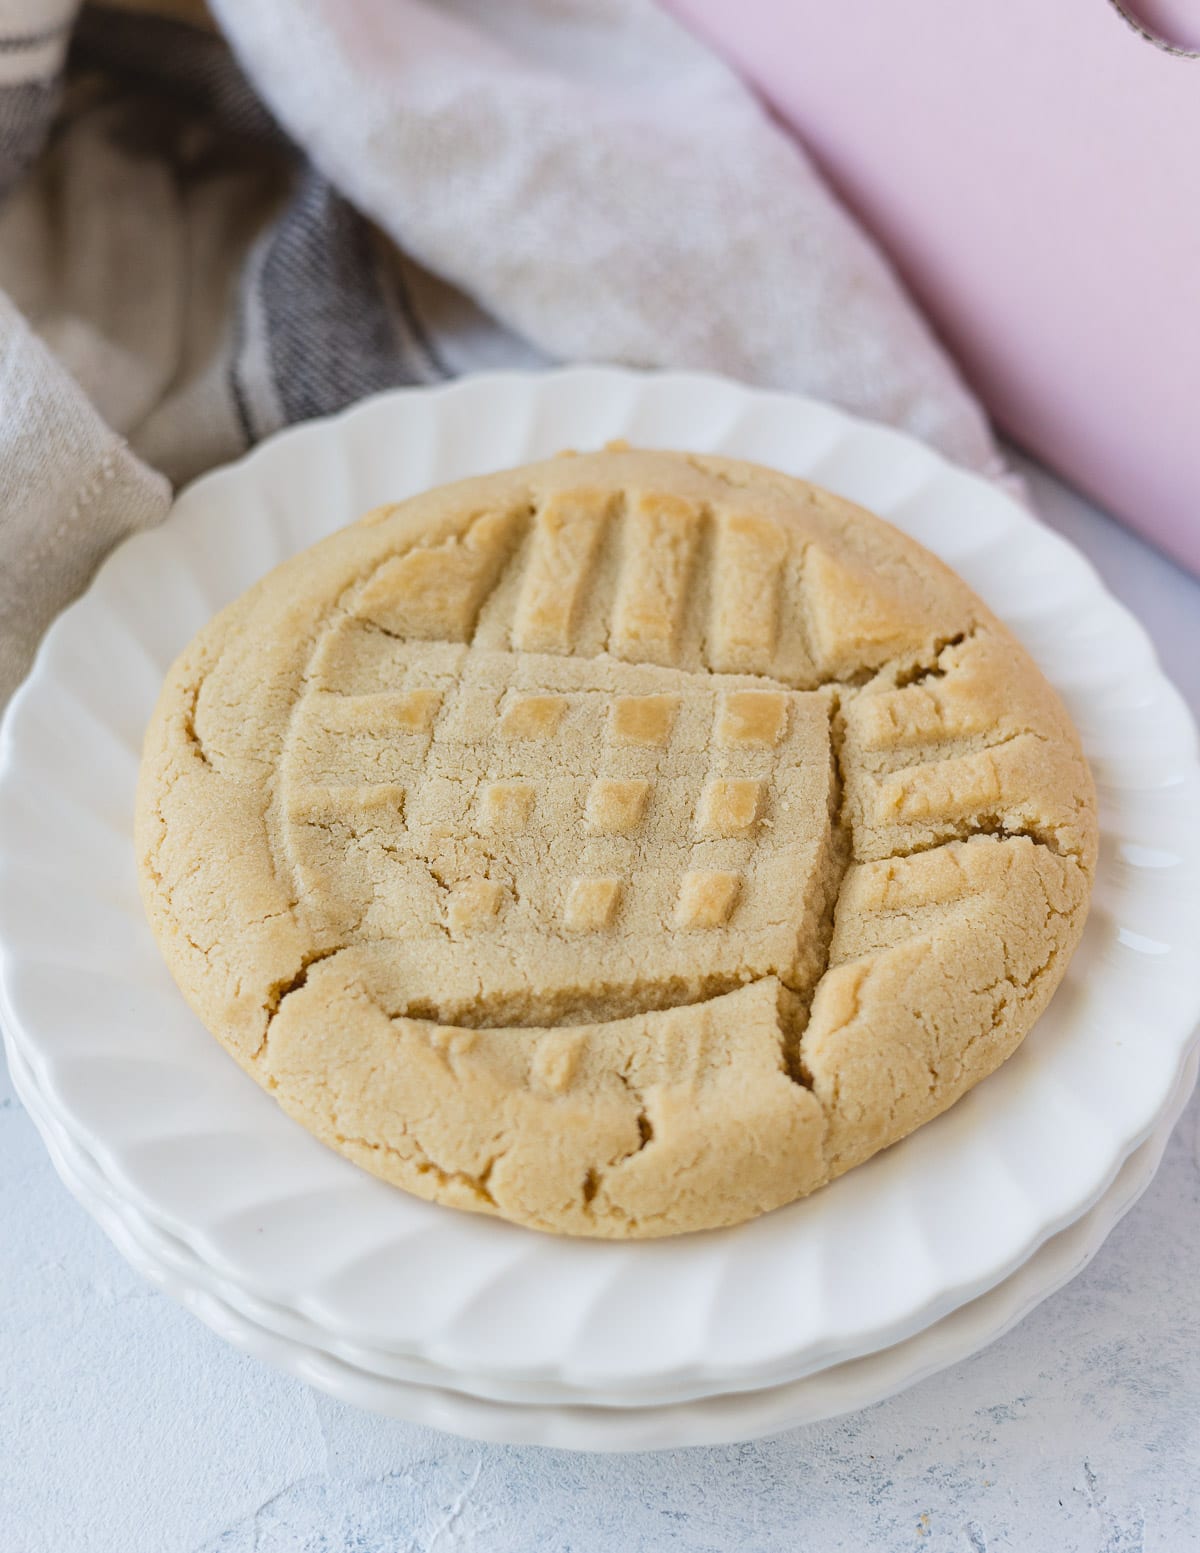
[669,0,1200,572]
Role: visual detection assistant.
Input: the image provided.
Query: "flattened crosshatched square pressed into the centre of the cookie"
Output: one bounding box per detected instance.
[286,658,829,969]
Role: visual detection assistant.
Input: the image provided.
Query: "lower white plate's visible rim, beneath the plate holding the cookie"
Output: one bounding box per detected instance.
[6,1041,1200,1451]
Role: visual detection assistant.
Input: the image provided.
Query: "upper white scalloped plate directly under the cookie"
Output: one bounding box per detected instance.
[0,368,1200,1401]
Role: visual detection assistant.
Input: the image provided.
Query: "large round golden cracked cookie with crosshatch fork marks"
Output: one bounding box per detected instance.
[137,450,1096,1236]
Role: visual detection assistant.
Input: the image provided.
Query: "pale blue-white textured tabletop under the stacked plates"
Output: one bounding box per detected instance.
[0,453,1200,1553]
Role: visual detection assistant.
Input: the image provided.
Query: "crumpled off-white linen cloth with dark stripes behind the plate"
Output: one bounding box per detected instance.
[0,0,997,704]
